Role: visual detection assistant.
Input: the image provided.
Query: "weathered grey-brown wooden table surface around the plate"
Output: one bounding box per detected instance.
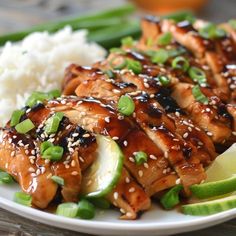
[0,0,236,236]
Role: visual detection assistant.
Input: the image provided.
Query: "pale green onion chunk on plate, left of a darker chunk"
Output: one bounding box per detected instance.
[56,202,78,218]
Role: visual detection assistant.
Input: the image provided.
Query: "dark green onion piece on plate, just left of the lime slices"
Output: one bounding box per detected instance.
[160,185,183,210]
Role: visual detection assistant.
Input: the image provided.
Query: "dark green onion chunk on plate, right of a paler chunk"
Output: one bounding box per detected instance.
[77,199,95,219]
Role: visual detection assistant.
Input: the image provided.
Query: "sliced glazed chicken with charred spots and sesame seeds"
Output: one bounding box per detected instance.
[0,17,236,219]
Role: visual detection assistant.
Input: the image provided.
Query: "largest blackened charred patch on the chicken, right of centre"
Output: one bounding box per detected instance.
[155,87,185,115]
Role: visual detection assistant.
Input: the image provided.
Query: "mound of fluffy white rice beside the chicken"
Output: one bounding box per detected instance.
[0,27,106,126]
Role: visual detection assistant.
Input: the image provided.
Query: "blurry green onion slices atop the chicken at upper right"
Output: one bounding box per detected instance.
[199,23,226,39]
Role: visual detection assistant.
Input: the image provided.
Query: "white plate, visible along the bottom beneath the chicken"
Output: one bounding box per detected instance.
[0,185,236,236]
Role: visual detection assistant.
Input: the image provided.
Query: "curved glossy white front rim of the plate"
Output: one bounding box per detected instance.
[0,193,236,234]
